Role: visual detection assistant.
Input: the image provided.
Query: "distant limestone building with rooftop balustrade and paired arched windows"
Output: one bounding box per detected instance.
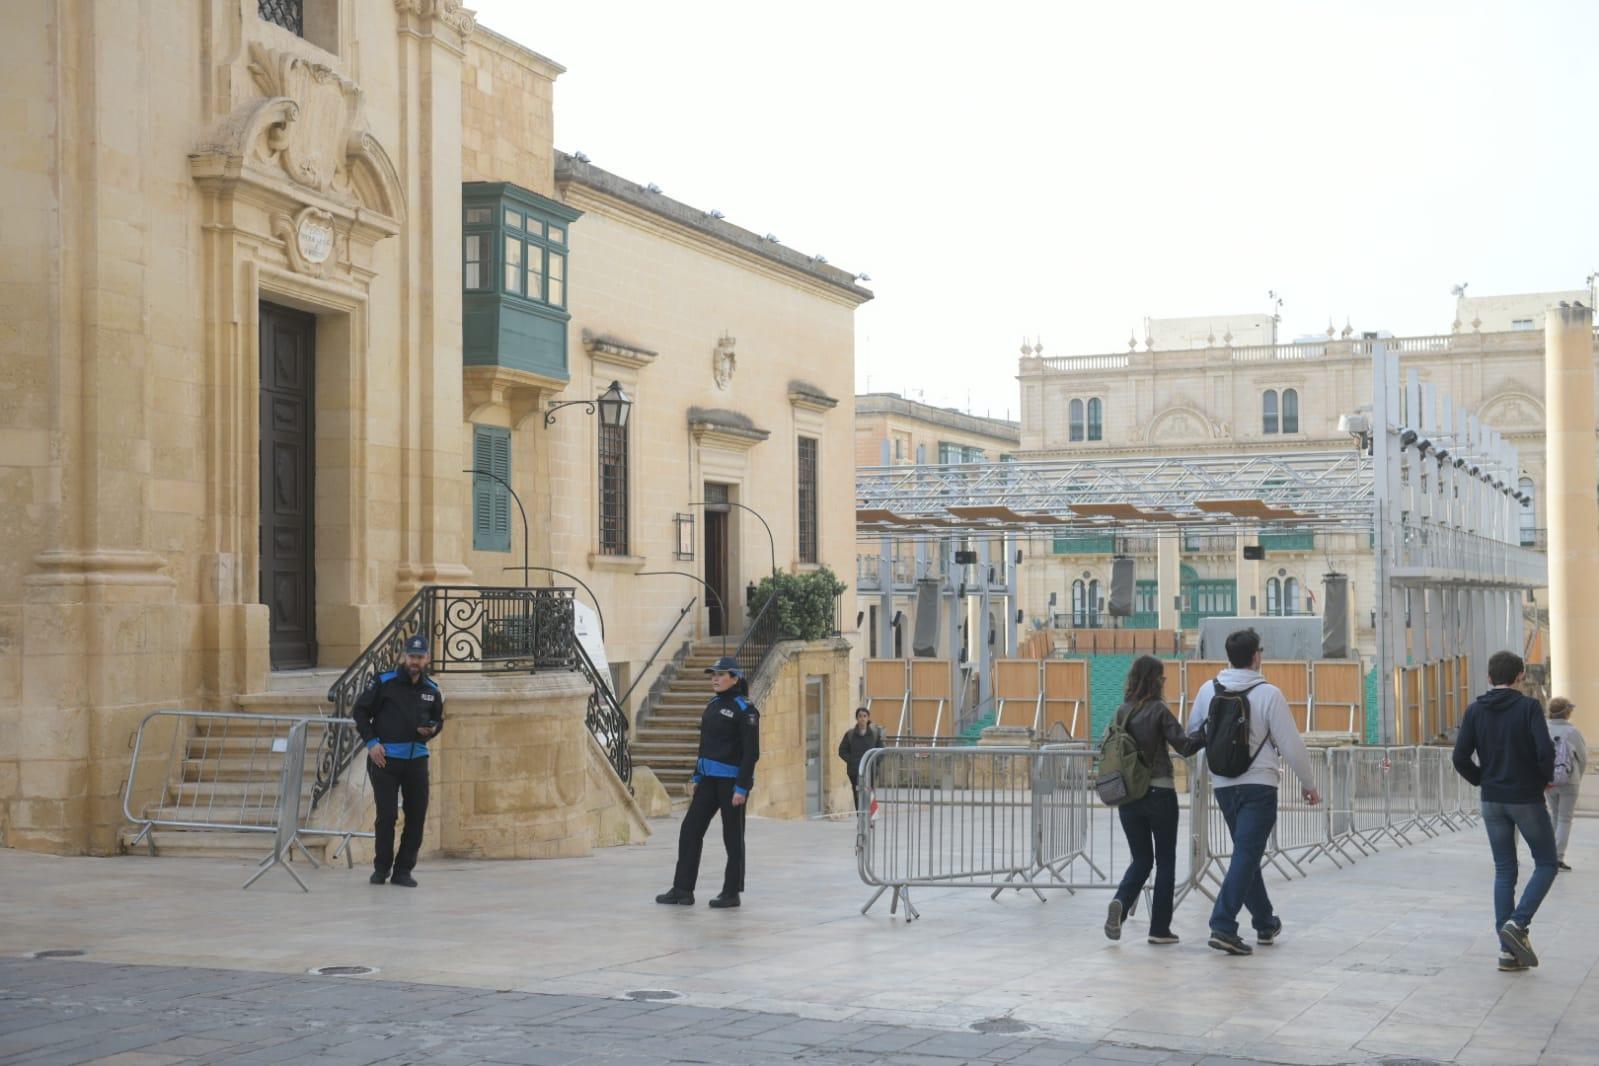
[1019,300,1560,649]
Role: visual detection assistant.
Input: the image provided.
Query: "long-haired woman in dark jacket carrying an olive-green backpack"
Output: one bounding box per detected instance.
[1105,655,1204,945]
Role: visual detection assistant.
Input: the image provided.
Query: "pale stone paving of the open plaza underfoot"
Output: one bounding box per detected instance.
[0,820,1599,1066]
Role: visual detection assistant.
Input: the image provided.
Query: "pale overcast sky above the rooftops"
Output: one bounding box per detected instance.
[467,0,1599,417]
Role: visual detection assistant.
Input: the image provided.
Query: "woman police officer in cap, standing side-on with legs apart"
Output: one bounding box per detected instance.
[656,655,761,908]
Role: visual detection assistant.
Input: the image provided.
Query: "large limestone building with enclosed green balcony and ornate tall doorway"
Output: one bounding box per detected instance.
[0,0,870,853]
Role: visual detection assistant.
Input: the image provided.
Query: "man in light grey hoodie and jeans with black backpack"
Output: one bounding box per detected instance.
[1188,630,1321,956]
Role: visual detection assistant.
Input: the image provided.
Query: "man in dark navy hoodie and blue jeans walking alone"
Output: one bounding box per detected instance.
[1453,652,1559,972]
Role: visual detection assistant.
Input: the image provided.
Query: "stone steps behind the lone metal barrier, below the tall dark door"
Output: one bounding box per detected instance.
[120,670,342,861]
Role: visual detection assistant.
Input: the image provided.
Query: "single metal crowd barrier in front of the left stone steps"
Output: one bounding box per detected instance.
[122,711,373,889]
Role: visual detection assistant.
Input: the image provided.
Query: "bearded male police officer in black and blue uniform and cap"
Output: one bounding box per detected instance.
[352,636,445,889]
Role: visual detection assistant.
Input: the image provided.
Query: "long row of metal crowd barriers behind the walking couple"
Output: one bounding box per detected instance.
[855,745,1477,921]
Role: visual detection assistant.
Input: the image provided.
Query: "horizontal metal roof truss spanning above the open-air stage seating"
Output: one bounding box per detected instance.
[855,443,1375,534]
